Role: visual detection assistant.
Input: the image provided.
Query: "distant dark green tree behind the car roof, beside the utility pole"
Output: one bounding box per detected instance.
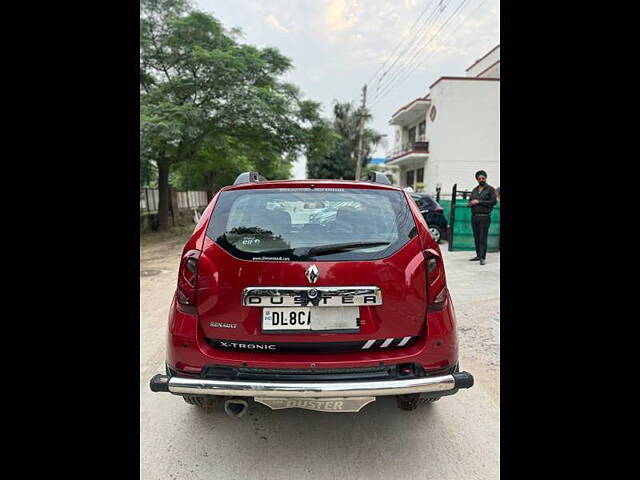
[307,102,382,179]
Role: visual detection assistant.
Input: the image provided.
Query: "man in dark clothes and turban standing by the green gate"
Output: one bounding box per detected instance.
[468,170,497,265]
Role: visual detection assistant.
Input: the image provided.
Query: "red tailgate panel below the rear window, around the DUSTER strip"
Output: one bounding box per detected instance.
[196,237,426,342]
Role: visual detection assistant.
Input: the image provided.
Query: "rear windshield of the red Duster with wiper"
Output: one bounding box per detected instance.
[207,188,416,261]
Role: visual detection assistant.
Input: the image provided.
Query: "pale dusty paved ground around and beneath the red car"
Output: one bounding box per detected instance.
[140,231,500,480]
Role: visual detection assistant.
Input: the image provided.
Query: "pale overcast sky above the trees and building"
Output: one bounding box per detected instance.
[195,0,500,178]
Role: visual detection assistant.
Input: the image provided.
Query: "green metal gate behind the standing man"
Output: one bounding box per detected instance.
[449,184,500,252]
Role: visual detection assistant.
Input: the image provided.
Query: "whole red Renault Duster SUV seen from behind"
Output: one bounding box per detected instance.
[151,172,473,416]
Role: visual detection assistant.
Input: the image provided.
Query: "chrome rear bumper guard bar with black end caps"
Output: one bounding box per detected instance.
[150,372,473,398]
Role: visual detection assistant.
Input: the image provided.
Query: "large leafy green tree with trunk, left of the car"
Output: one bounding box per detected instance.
[140,0,318,230]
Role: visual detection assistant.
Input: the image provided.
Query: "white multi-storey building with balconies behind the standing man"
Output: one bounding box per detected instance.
[386,45,500,197]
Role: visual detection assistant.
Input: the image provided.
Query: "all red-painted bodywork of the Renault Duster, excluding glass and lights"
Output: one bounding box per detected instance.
[167,180,458,375]
